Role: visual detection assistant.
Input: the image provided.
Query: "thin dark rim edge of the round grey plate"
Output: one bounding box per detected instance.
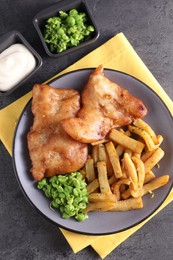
[12,67,173,236]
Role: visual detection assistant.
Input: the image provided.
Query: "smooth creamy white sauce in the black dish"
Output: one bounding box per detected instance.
[0,43,36,91]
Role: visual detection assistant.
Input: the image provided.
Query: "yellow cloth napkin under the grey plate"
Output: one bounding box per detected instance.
[0,33,173,259]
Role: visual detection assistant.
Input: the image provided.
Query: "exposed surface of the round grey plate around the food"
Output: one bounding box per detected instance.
[13,69,173,235]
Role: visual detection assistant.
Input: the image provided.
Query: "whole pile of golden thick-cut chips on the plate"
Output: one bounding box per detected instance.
[83,119,169,212]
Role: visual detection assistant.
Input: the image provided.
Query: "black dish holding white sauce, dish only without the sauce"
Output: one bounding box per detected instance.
[0,31,42,97]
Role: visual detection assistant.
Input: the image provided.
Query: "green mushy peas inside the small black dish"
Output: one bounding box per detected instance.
[44,9,95,53]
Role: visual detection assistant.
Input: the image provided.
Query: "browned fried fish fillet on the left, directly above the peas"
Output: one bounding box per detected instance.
[27,84,88,180]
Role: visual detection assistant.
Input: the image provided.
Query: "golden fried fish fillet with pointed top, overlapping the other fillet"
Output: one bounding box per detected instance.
[61,65,147,143]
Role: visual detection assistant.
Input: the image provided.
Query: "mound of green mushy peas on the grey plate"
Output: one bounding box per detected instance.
[37,172,88,221]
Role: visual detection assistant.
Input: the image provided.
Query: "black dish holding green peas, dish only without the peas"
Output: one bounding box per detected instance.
[33,0,99,58]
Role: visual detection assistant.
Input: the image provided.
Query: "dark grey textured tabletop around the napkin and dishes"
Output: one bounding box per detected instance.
[0,0,173,260]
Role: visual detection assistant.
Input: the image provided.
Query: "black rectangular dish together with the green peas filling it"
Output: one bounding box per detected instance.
[33,0,99,58]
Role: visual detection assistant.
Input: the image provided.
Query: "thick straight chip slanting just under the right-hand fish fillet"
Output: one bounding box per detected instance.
[109,129,145,154]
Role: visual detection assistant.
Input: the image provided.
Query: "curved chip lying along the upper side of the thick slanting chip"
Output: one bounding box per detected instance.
[128,125,156,151]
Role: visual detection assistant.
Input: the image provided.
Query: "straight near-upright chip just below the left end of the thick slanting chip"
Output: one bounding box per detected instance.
[105,142,122,178]
